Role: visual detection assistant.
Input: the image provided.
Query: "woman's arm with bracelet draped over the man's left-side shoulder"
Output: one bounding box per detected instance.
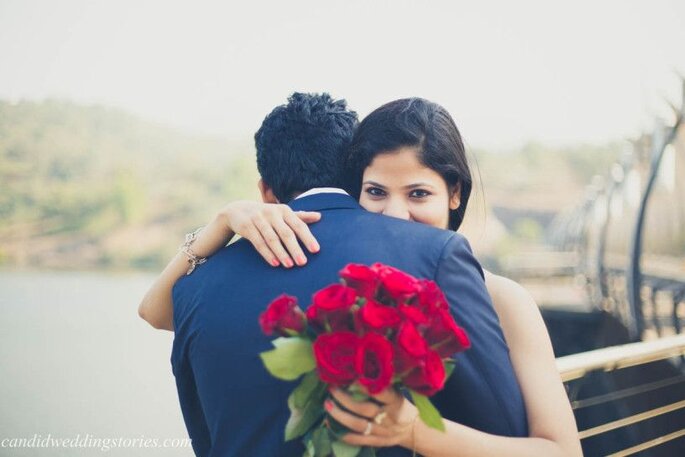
[138,201,321,331]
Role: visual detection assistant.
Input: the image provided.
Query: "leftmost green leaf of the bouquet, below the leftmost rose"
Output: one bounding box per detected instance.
[259,337,316,381]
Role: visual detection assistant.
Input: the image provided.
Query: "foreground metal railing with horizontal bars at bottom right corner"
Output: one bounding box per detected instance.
[557,335,685,457]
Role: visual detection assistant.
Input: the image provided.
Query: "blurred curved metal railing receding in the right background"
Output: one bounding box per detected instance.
[549,77,685,341]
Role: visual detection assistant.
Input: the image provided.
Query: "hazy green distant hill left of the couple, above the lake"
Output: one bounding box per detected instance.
[0,100,257,268]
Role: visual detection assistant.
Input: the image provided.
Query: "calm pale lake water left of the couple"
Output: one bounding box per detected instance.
[0,271,193,457]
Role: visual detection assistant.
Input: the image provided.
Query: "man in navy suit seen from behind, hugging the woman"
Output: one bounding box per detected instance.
[171,94,527,457]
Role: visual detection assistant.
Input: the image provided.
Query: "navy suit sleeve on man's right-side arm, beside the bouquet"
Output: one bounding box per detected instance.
[435,234,526,436]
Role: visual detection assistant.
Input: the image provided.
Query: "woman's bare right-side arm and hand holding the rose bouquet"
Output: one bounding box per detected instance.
[327,275,582,457]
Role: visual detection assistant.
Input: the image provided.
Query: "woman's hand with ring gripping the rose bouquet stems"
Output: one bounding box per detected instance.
[324,388,418,449]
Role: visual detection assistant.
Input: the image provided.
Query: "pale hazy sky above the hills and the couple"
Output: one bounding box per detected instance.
[0,0,685,148]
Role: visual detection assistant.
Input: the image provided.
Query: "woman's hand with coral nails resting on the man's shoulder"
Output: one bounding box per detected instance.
[219,201,321,268]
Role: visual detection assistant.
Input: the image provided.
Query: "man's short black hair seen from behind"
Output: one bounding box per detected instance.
[255,92,357,203]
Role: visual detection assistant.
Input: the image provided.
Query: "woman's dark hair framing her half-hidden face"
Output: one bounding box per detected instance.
[346,98,472,230]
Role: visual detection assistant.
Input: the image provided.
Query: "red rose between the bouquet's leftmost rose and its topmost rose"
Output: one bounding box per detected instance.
[307,284,357,331]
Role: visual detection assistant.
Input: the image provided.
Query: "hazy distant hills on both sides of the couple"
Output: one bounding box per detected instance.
[0,100,621,269]
